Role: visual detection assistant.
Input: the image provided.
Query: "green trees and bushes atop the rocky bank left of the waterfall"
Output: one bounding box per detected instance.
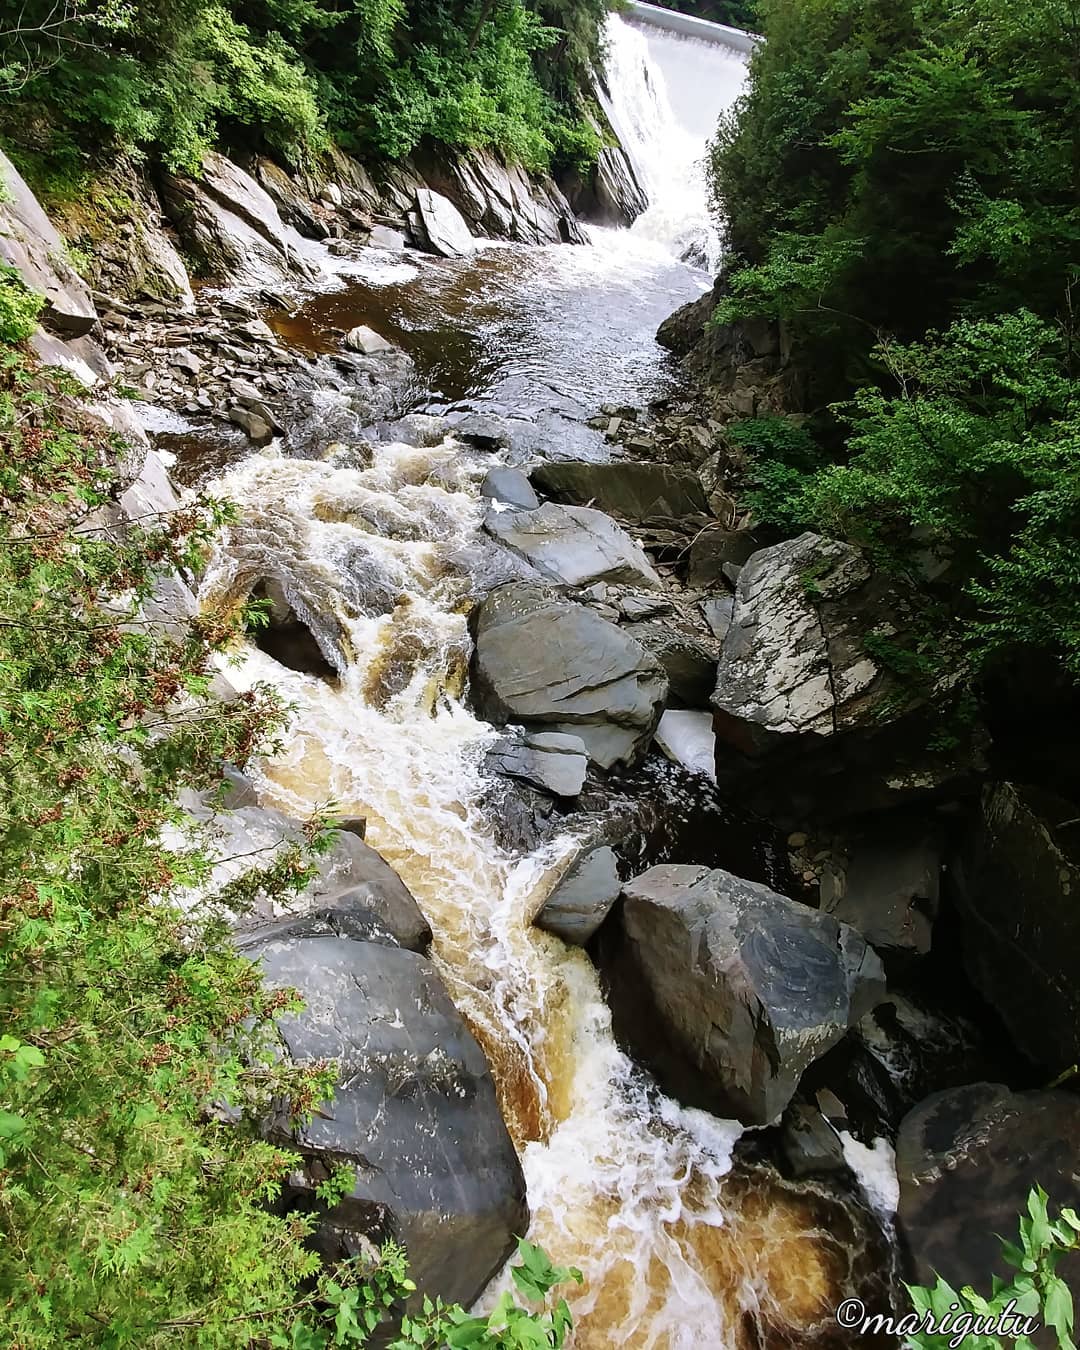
[0,0,606,178]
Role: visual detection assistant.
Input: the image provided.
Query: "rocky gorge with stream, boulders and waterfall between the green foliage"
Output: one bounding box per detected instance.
[0,5,1076,1350]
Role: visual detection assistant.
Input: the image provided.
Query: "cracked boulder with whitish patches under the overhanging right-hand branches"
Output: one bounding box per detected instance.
[713,533,984,821]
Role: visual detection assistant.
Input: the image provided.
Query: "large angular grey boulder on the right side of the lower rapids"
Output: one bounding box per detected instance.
[602,864,886,1125]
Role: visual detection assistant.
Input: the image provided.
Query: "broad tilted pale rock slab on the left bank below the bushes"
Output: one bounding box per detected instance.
[162,151,316,288]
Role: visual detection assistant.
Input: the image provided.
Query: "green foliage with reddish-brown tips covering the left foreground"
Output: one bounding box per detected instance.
[0,346,591,1350]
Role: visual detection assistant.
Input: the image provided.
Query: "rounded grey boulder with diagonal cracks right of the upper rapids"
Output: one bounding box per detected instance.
[473,583,667,768]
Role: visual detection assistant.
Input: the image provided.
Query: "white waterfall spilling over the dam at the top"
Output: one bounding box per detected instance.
[601,15,747,271]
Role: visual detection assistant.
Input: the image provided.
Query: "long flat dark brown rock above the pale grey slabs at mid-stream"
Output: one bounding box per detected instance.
[532,459,709,521]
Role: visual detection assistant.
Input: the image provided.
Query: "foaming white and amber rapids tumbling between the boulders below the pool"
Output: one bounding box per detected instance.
[204,437,880,1350]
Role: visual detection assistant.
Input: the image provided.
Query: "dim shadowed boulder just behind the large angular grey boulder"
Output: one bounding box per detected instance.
[821,817,941,956]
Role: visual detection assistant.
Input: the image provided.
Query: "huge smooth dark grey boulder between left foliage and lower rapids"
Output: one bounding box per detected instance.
[240,917,529,1305]
